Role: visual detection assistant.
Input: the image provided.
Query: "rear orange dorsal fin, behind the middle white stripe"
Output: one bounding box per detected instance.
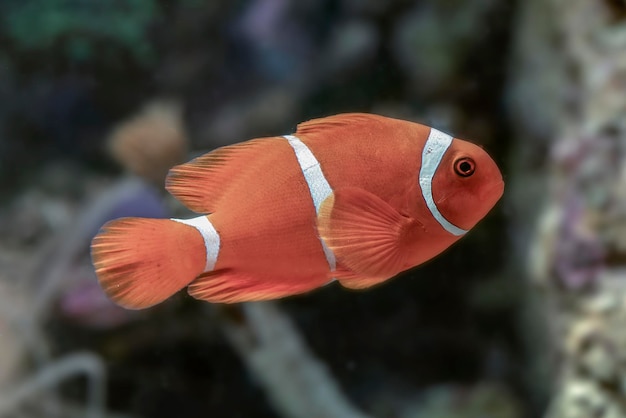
[165,137,284,214]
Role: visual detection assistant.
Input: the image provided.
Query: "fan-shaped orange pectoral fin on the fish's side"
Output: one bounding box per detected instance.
[318,188,422,280]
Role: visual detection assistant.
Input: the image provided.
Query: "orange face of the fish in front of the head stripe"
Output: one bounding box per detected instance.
[432,139,504,230]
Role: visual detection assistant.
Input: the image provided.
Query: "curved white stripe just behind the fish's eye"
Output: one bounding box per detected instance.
[419,128,467,236]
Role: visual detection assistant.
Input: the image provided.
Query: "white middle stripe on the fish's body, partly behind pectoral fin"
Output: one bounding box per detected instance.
[284,135,337,271]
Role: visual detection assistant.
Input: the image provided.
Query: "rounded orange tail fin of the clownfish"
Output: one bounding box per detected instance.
[91,218,207,309]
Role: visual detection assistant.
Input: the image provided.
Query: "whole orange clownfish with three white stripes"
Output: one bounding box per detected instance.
[91,113,504,309]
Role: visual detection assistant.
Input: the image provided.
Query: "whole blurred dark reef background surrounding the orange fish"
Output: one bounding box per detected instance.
[0,0,626,418]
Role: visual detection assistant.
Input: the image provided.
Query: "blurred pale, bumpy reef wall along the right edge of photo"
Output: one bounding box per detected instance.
[510,0,626,418]
